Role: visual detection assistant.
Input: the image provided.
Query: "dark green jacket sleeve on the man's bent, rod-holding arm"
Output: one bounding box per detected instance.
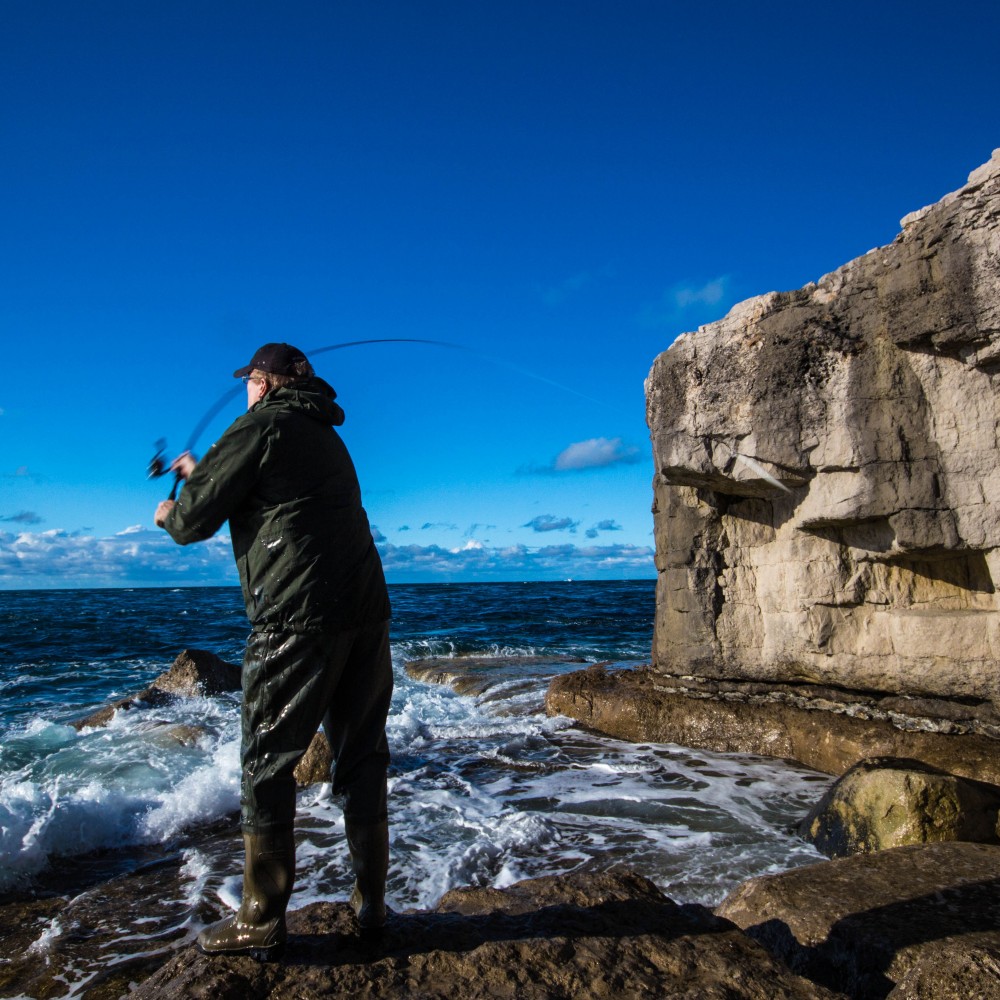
[163,414,265,545]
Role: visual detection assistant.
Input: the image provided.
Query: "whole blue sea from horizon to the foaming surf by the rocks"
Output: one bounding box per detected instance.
[0,581,830,998]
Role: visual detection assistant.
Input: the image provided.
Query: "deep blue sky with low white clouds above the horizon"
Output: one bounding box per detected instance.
[0,0,1000,588]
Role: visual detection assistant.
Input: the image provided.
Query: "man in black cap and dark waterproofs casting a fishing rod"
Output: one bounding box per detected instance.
[154,344,392,960]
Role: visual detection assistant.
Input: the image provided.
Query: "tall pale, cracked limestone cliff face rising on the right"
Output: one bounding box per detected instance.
[646,150,1000,707]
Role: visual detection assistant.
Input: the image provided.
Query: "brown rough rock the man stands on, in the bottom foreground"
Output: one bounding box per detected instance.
[131,872,833,1000]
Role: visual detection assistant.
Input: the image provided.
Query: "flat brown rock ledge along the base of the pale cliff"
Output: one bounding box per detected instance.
[545,665,1000,785]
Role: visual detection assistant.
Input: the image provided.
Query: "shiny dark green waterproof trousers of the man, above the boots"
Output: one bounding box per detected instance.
[240,622,392,833]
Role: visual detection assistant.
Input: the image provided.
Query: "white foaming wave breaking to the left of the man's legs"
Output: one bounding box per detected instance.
[0,698,239,888]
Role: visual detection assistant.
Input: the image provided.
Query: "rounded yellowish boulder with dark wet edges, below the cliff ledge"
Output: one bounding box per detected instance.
[799,758,1000,858]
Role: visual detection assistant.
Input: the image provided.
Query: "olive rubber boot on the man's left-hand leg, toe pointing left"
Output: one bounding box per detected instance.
[198,827,295,962]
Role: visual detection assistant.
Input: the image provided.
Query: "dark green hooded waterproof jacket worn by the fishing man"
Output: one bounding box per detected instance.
[164,379,389,632]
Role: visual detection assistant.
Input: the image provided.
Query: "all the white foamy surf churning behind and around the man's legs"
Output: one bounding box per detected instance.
[0,643,820,908]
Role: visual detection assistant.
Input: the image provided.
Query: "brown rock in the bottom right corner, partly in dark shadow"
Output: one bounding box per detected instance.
[716,842,1000,1000]
